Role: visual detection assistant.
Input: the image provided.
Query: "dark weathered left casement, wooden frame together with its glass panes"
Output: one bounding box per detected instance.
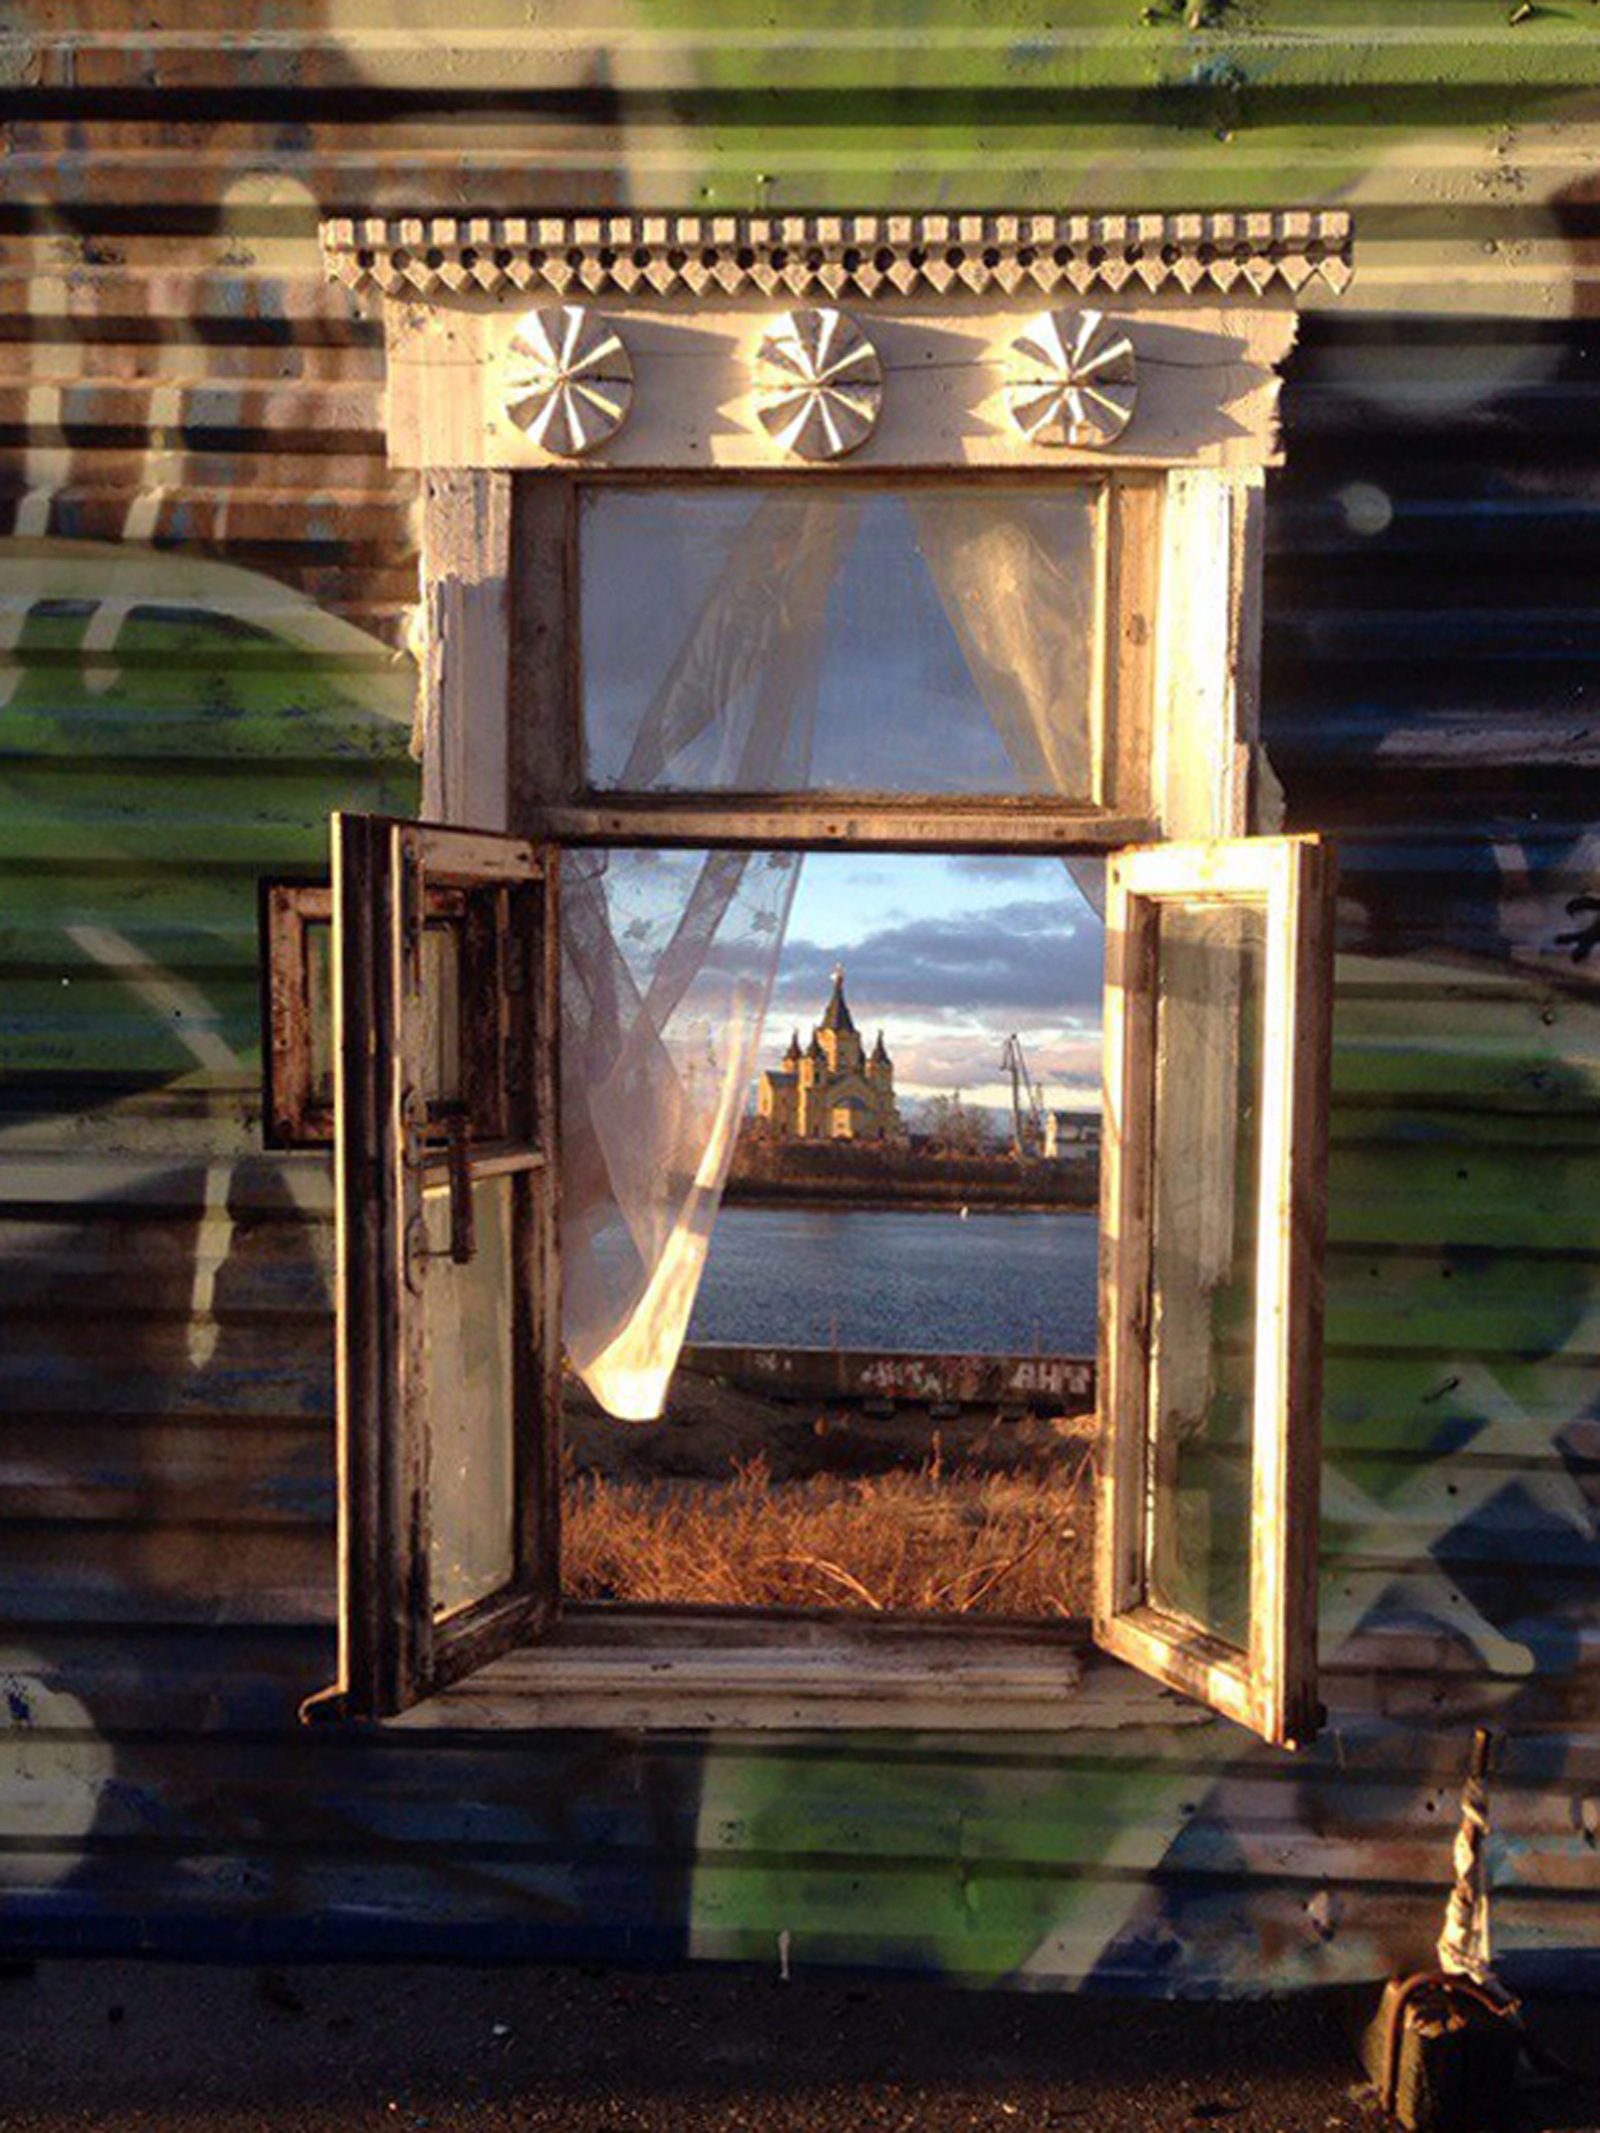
[313,815,561,1717]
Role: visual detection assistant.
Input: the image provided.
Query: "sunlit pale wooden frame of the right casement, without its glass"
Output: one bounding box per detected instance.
[1094,838,1335,1747]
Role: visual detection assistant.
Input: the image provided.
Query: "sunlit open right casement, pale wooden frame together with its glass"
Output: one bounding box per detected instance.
[1094,838,1333,1747]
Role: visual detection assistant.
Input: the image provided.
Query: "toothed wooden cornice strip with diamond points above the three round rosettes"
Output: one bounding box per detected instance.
[322,207,1353,301]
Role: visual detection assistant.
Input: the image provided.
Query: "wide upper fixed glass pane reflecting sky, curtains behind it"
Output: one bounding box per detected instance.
[580,484,1099,800]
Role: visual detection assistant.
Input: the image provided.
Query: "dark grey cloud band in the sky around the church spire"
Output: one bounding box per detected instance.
[777,896,1103,1022]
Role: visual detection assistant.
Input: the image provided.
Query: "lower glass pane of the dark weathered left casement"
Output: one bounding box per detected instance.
[422,1177,516,1617]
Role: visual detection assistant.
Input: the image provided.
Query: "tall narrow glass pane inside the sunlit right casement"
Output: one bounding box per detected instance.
[1148,902,1267,1649]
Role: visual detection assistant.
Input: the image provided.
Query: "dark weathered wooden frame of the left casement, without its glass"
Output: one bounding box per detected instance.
[311,815,561,1717]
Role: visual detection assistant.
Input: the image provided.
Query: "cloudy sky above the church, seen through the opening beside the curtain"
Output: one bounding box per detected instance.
[764,853,1103,1107]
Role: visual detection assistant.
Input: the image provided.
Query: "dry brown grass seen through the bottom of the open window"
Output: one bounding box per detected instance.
[561,1453,1090,1617]
